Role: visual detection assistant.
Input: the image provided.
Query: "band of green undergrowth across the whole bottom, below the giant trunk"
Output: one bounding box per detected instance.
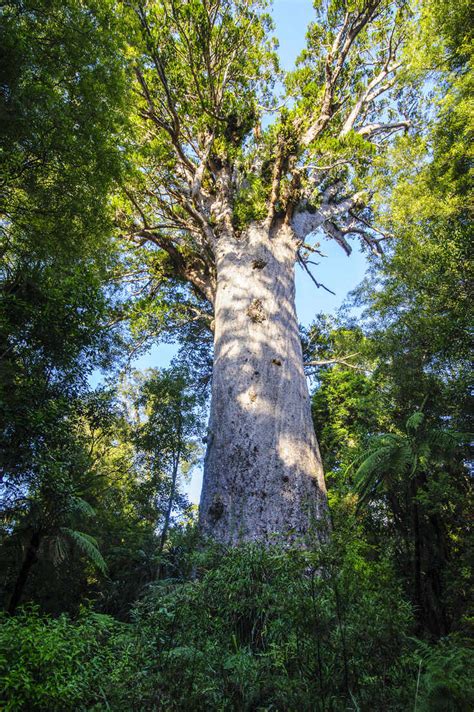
[0,537,472,712]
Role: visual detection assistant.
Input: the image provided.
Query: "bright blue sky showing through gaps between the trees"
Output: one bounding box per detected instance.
[134,0,366,503]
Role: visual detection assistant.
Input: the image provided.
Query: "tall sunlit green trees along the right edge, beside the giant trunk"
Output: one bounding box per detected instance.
[306,0,472,636]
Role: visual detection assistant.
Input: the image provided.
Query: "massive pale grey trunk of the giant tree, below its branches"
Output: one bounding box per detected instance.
[200,224,327,544]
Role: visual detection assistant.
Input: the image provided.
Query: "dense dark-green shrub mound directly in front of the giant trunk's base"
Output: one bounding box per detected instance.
[115,546,417,710]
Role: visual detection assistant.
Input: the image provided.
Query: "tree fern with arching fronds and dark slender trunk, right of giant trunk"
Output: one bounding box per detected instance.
[351,410,472,634]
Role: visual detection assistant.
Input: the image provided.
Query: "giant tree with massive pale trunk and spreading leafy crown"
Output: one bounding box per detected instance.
[118,0,418,543]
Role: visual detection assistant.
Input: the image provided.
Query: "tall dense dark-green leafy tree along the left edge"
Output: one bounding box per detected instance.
[0,0,130,610]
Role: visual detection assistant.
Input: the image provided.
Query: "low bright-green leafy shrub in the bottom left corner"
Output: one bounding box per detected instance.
[0,608,126,712]
